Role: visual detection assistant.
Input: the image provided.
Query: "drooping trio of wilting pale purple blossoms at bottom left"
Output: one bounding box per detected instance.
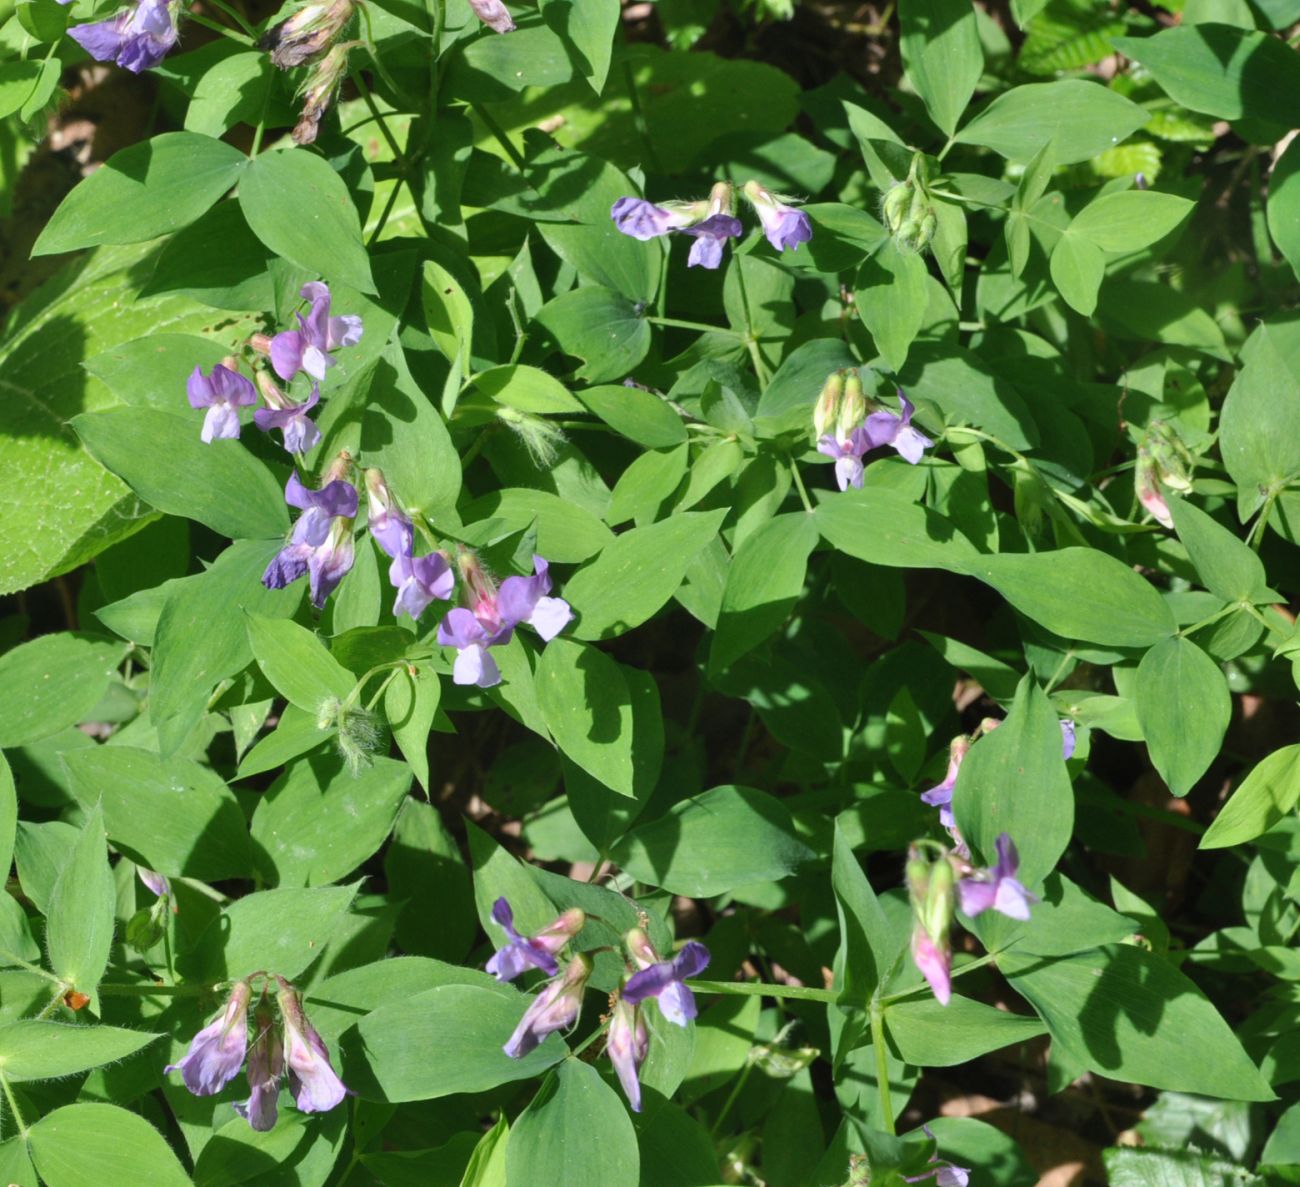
[165,972,347,1131]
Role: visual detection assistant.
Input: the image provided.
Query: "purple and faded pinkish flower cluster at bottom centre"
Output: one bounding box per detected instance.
[488,898,709,1113]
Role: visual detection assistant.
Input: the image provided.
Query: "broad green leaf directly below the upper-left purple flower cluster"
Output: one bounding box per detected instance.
[72,408,289,540]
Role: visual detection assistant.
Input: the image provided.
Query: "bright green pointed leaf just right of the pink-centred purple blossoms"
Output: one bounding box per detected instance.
[564,511,727,640]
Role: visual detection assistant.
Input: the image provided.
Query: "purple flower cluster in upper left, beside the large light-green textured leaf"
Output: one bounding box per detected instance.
[186,281,361,455]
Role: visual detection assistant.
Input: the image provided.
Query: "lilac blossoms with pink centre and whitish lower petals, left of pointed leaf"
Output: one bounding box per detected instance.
[438,553,573,688]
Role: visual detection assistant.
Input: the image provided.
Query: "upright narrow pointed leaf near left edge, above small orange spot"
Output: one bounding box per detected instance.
[46,805,117,997]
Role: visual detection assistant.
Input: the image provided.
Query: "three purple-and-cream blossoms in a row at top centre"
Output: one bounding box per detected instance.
[610,181,813,268]
